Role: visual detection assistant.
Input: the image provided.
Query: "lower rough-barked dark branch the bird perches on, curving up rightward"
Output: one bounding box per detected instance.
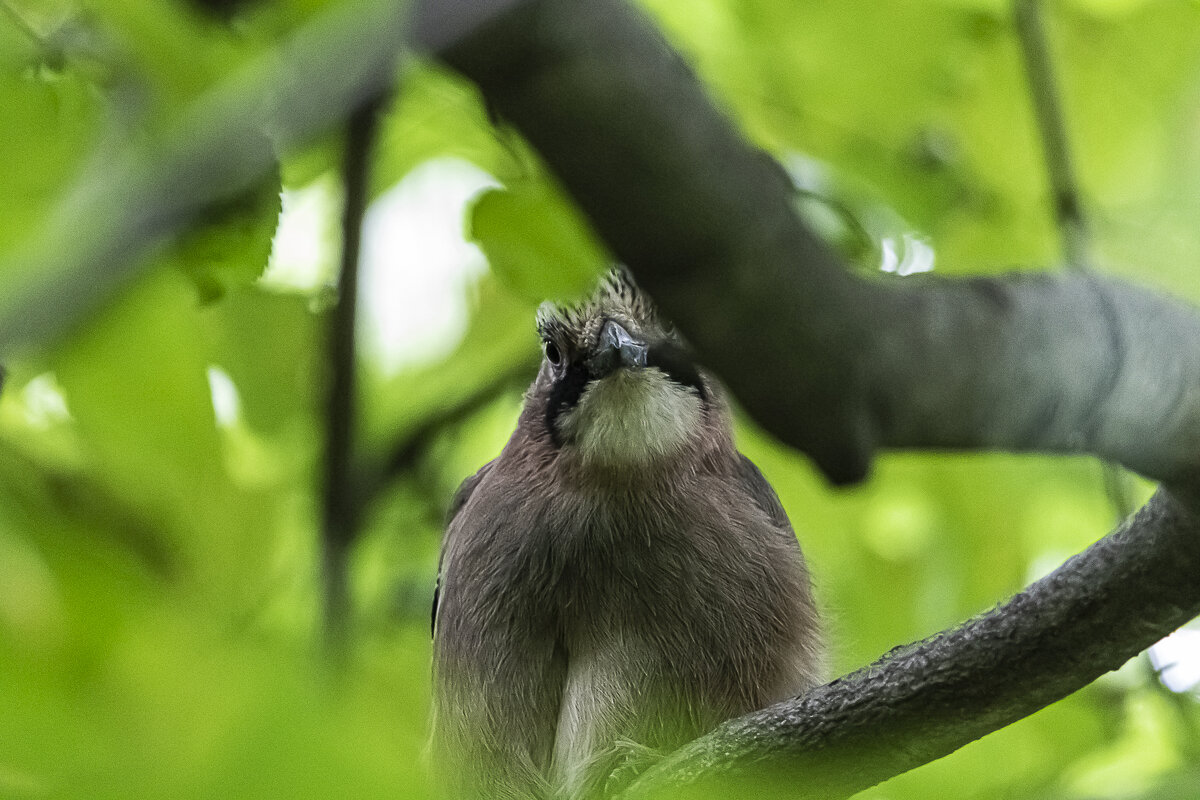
[628,491,1200,800]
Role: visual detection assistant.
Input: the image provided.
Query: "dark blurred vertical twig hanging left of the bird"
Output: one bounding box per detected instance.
[320,98,380,662]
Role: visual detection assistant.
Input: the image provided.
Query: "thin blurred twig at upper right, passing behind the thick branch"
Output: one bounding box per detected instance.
[1014,0,1136,519]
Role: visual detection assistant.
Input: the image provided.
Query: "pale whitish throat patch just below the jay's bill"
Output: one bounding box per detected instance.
[560,368,703,467]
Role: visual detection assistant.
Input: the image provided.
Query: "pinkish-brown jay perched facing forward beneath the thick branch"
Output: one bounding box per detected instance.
[430,267,824,800]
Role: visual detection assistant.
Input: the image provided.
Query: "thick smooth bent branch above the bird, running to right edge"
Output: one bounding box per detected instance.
[446,0,1200,482]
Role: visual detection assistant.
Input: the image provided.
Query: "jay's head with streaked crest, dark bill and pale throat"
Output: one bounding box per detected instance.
[529,270,720,468]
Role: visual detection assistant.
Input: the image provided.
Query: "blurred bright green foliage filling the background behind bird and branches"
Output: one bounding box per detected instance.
[0,0,1200,800]
